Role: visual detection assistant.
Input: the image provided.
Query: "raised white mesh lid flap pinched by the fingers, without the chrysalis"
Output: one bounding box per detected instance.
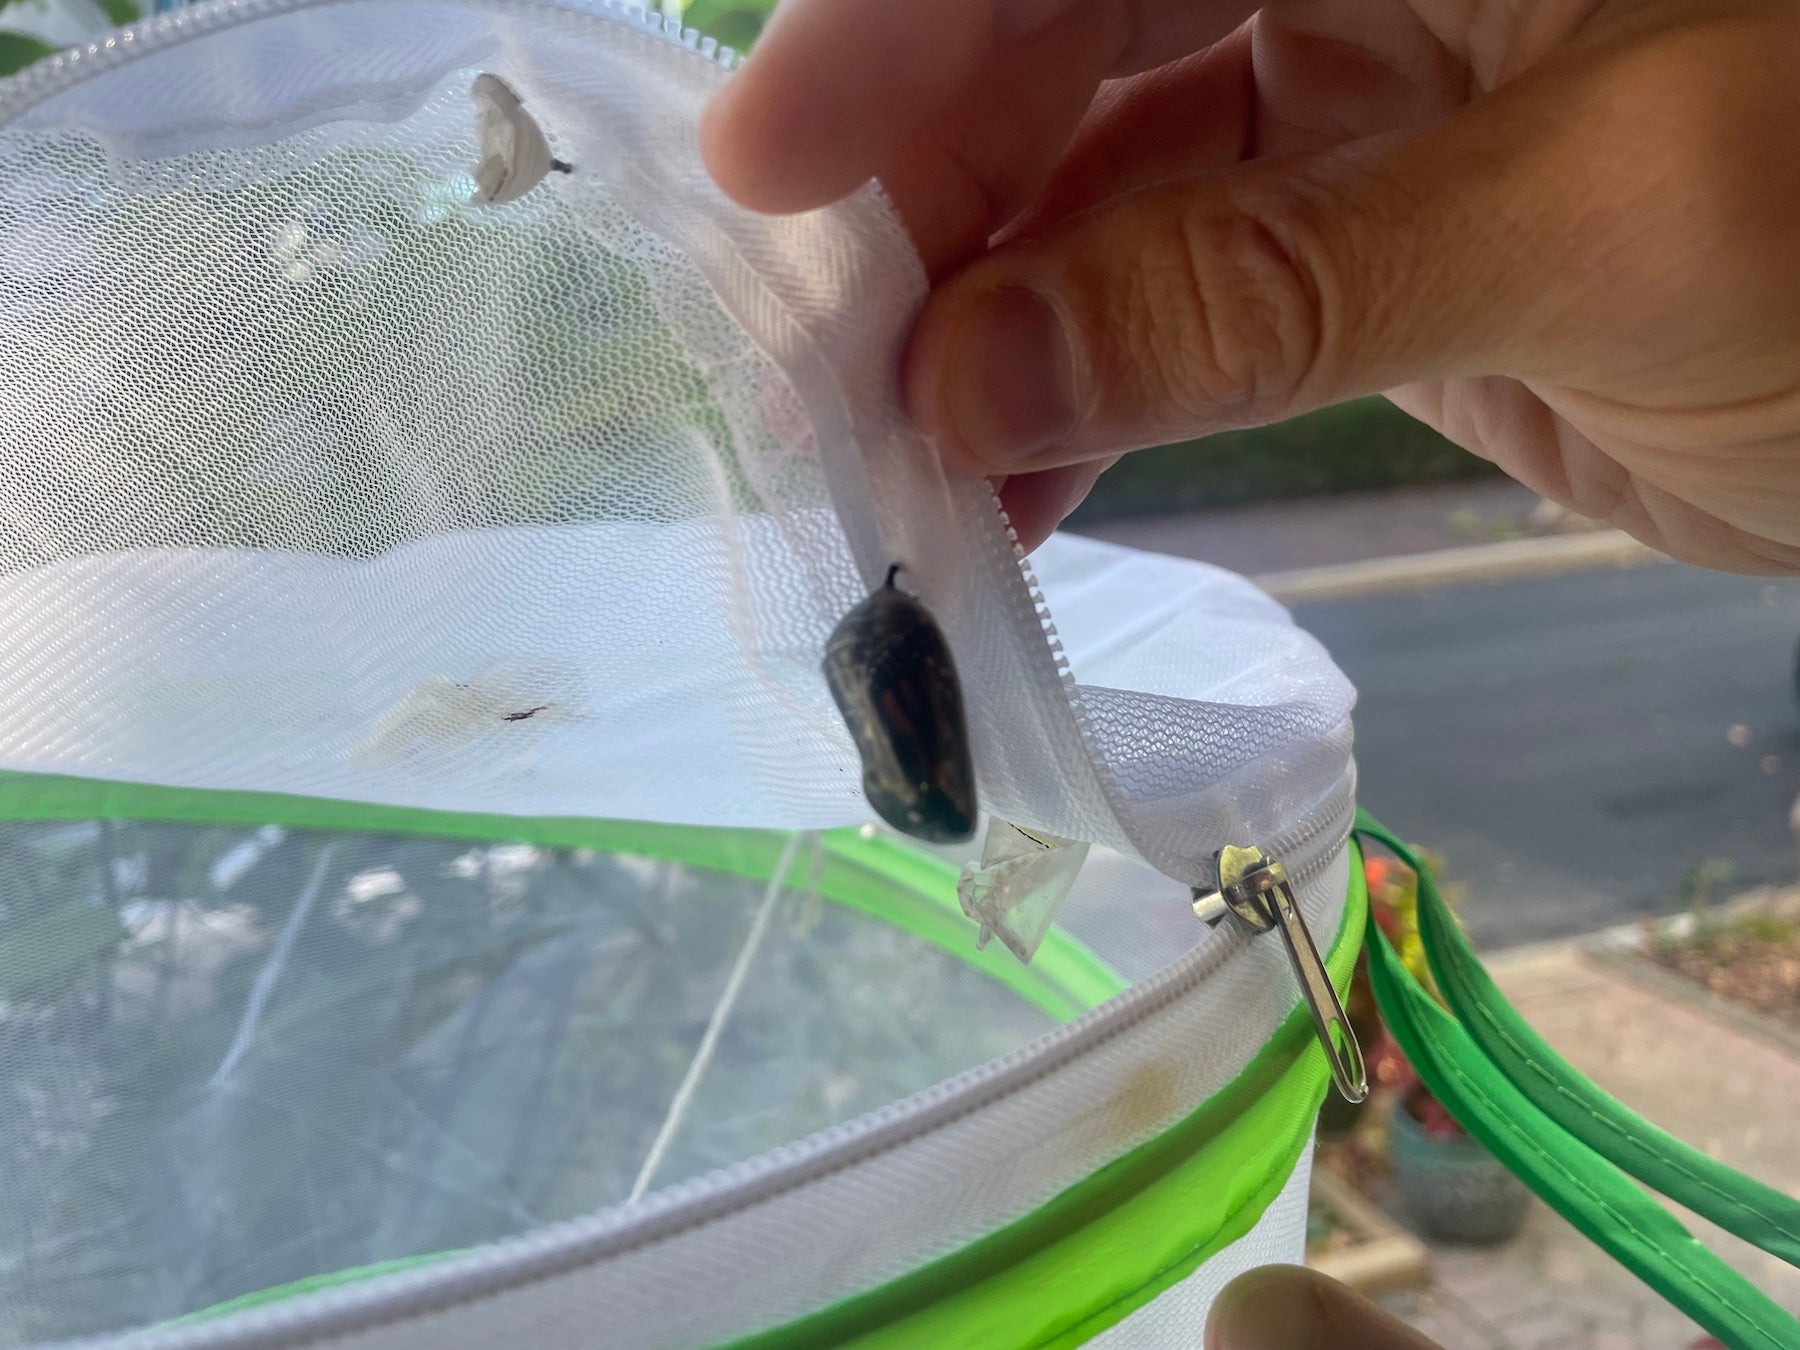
[0,0,1350,882]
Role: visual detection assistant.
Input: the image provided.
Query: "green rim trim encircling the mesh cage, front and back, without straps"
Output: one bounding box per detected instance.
[0,772,1368,1350]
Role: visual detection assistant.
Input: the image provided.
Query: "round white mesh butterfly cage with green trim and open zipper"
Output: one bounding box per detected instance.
[0,0,1363,1350]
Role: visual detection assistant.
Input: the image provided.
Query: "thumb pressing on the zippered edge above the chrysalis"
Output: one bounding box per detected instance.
[905,95,1591,473]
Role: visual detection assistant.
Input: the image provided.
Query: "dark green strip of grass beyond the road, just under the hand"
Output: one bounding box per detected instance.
[1073,398,1499,524]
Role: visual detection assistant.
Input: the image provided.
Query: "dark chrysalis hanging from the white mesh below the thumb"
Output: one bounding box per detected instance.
[824,565,976,844]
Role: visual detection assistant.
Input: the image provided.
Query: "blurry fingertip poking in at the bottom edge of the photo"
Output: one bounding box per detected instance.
[1206,1265,1438,1350]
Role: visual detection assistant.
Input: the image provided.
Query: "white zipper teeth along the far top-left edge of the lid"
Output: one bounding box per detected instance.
[0,0,742,130]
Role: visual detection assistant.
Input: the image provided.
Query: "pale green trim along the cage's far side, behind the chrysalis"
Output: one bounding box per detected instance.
[0,772,1125,1022]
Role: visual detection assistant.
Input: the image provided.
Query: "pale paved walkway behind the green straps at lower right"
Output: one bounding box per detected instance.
[1382,945,1800,1350]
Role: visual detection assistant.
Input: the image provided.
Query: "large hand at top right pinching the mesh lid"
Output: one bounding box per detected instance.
[702,0,1800,572]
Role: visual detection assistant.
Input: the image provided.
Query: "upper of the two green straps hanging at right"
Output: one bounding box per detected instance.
[1359,819,1800,1265]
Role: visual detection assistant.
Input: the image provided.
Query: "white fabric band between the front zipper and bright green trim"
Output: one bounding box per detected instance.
[81,851,1348,1350]
